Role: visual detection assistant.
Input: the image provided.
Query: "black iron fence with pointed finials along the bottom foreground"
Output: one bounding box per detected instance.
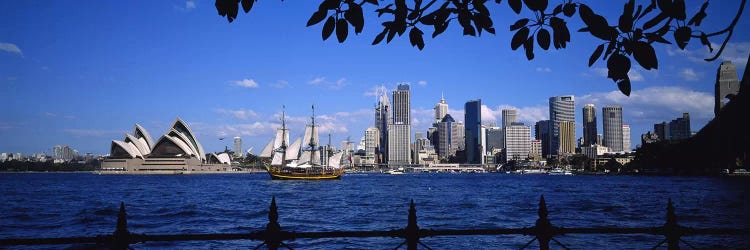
[0,195,750,250]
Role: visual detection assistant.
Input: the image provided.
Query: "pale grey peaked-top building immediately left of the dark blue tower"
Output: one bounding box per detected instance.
[437,114,464,160]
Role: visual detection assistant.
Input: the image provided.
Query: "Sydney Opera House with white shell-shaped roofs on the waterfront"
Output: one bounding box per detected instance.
[101,118,232,173]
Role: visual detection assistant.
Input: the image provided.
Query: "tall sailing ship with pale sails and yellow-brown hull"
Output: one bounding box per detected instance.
[260,106,344,180]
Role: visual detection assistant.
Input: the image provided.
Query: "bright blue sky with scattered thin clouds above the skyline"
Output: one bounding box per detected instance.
[0,0,750,154]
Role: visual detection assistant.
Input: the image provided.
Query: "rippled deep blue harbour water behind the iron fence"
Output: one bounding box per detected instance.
[0,173,750,249]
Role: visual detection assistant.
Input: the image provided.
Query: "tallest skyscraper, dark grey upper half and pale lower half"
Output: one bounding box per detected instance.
[388,84,411,166]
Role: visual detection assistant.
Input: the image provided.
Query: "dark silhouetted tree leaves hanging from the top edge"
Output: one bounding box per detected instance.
[215,0,747,96]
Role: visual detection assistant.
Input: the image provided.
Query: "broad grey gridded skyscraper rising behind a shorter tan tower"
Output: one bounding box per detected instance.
[542,95,576,155]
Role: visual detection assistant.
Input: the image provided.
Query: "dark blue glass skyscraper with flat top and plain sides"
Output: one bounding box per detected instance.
[464,99,484,164]
